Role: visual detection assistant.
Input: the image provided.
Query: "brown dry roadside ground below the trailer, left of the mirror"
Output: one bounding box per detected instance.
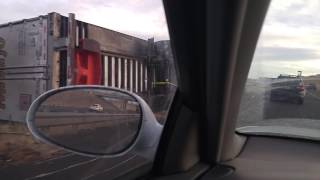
[0,121,64,167]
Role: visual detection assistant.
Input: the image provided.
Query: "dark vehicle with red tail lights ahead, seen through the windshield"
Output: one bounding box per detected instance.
[270,78,306,104]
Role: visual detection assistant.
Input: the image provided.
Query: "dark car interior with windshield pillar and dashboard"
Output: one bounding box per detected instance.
[127,0,320,180]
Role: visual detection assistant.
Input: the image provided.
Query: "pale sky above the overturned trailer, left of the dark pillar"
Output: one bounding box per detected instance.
[0,0,169,40]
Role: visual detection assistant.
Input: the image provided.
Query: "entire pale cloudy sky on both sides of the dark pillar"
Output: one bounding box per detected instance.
[0,0,320,78]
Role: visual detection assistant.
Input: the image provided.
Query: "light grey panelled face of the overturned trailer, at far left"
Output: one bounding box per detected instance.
[0,17,48,122]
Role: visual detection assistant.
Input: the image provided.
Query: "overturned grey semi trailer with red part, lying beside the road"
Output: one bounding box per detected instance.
[0,13,172,122]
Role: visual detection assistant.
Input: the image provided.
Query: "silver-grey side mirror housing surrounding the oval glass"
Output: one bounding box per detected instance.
[26,85,162,159]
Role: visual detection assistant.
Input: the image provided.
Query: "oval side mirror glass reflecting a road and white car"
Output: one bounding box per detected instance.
[33,88,142,154]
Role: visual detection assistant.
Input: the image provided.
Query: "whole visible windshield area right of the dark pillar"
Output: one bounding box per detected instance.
[237,0,320,139]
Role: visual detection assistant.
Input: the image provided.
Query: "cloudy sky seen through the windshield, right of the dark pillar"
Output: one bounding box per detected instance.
[249,0,320,78]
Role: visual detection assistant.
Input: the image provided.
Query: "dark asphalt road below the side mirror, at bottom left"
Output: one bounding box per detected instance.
[0,153,149,180]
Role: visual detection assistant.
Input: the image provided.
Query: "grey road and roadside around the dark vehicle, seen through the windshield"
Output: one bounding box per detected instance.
[237,80,320,129]
